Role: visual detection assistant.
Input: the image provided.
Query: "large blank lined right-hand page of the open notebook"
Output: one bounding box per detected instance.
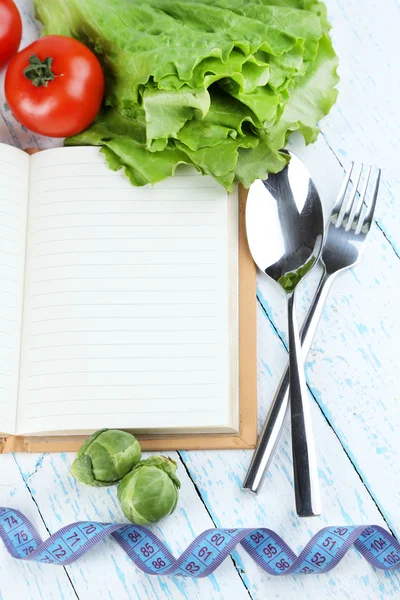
[19,148,234,431]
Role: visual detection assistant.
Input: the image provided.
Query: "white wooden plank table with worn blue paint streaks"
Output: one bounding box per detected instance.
[0,0,400,600]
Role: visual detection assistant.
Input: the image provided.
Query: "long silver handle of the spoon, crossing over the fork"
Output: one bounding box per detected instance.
[288,292,321,517]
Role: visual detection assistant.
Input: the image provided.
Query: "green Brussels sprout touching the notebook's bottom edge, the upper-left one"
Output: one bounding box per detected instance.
[71,429,142,486]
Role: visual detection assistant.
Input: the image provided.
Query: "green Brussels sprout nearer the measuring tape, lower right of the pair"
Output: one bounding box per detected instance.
[118,456,181,525]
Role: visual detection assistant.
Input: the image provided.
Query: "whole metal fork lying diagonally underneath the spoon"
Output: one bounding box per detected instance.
[243,163,381,494]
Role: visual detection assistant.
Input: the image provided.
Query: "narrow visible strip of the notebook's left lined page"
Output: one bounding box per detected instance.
[0,144,29,433]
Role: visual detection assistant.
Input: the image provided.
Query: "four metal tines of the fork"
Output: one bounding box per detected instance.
[331,163,381,234]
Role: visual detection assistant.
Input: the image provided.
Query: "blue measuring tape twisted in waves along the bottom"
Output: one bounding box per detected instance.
[0,508,400,577]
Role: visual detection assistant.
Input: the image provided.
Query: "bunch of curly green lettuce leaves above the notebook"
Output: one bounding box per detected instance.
[35,0,338,190]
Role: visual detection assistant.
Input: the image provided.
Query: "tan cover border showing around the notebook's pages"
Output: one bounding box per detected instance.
[0,187,257,454]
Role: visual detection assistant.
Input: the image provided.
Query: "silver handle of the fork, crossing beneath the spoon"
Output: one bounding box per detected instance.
[243,265,335,494]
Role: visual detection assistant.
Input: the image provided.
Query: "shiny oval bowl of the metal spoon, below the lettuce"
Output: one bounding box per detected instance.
[246,153,324,292]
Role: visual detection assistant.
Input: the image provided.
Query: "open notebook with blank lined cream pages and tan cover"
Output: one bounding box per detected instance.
[0,144,255,449]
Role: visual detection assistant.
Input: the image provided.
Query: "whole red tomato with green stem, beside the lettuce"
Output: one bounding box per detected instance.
[5,35,104,137]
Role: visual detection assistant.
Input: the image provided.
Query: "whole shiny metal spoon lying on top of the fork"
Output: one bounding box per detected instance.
[246,153,324,517]
